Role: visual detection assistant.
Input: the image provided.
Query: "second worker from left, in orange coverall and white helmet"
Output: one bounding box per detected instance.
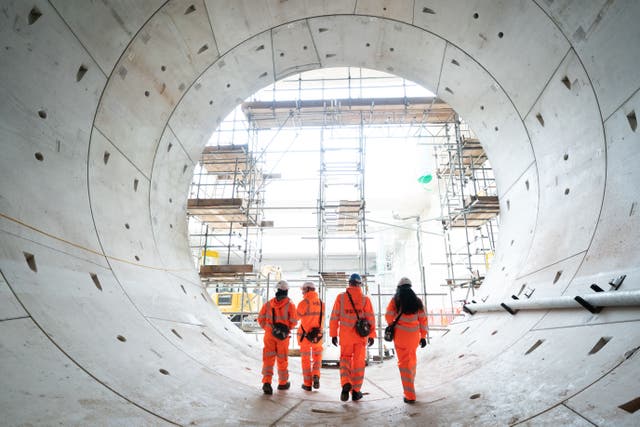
[298,282,325,391]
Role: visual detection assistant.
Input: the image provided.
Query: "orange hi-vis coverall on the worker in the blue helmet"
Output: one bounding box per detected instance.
[329,286,376,391]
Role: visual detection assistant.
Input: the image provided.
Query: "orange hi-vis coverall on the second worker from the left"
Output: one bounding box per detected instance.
[298,291,324,387]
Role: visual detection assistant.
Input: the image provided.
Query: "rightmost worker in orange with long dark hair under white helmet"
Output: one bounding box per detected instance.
[385,277,427,403]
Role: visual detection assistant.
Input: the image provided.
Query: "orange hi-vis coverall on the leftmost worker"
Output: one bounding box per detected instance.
[258,297,298,385]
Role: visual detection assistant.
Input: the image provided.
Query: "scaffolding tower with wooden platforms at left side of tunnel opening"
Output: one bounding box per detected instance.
[187,132,273,331]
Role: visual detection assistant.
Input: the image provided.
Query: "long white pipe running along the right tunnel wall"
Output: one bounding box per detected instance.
[464,290,640,313]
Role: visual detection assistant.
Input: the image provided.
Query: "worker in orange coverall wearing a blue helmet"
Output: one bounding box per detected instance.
[329,273,376,402]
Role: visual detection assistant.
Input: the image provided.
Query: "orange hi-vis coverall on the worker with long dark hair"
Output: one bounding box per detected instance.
[385,298,427,400]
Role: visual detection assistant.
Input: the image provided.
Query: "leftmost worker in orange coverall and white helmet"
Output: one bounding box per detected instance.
[258,280,298,394]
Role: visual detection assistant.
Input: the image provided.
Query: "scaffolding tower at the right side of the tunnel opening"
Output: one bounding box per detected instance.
[435,116,500,306]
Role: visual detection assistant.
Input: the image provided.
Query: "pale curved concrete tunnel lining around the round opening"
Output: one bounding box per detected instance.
[0,0,640,425]
